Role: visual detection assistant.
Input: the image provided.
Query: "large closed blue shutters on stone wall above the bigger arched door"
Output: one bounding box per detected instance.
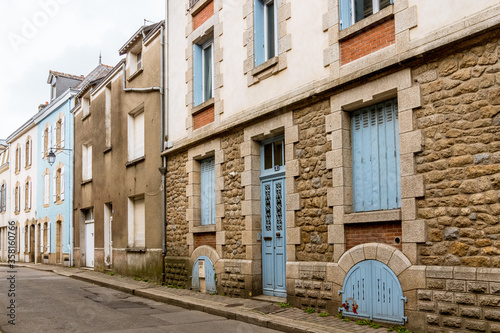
[351,99,401,212]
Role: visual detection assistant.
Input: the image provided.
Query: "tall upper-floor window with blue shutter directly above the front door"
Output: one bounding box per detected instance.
[254,0,278,66]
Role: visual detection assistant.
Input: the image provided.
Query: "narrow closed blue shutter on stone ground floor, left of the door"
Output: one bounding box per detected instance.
[200,157,215,225]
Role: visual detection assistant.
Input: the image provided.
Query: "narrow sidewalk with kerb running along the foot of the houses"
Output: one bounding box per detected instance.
[2,263,386,333]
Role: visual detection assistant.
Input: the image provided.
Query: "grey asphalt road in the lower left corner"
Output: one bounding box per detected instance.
[0,267,277,333]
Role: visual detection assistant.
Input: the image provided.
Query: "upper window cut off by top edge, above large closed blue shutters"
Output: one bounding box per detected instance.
[340,0,394,30]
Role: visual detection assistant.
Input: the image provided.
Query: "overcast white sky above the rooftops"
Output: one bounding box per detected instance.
[0,0,165,139]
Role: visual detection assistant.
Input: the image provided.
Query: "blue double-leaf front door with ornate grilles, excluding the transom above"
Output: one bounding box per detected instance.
[261,178,286,297]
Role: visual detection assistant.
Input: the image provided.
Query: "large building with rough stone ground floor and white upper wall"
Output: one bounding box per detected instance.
[163,0,500,332]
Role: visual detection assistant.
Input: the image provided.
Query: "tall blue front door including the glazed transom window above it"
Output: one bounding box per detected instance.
[261,138,286,297]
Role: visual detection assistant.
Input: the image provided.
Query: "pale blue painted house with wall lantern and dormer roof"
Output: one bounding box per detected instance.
[34,71,84,266]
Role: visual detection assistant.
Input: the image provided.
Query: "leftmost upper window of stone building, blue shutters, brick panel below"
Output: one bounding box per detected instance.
[193,39,214,106]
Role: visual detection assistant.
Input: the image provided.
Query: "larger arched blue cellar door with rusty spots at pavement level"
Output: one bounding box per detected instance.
[339,260,406,324]
